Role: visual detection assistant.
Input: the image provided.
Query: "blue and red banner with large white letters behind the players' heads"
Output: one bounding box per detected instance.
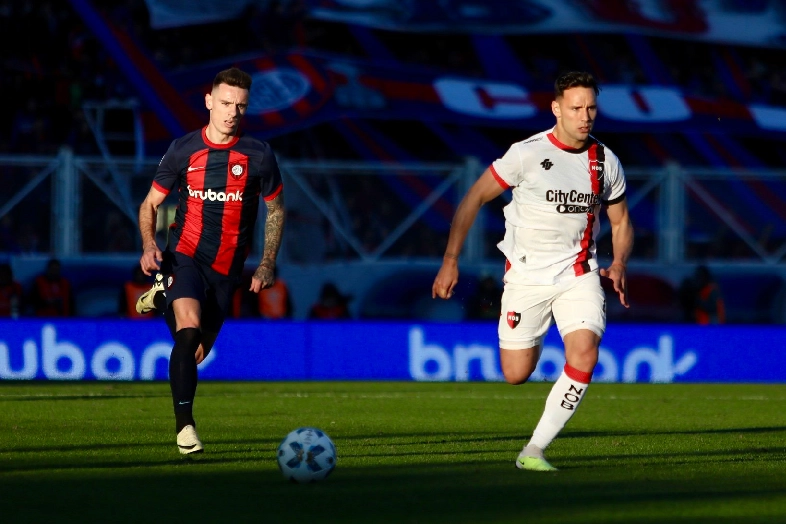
[161,52,786,139]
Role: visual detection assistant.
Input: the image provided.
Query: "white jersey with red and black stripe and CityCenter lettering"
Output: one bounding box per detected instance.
[490,129,626,284]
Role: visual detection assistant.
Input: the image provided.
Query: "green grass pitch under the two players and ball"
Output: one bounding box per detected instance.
[0,381,786,524]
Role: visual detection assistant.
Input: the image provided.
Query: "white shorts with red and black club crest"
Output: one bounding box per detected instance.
[497,269,606,349]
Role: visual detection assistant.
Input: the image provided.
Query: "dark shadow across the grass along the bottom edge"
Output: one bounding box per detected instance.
[0,460,786,524]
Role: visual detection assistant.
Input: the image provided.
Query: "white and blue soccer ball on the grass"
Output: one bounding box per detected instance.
[278,427,336,483]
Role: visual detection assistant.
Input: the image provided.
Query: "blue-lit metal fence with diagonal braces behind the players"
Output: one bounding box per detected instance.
[0,149,786,267]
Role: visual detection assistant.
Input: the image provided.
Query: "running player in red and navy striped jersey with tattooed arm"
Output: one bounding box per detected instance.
[137,68,284,454]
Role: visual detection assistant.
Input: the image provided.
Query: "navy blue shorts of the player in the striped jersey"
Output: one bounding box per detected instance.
[161,251,240,333]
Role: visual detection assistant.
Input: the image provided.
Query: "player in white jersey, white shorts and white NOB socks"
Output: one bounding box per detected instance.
[432,72,633,471]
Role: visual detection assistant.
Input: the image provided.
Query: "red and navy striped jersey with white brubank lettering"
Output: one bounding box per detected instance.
[153,128,283,275]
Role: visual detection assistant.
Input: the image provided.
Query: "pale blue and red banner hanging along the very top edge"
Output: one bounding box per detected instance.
[145,0,786,48]
